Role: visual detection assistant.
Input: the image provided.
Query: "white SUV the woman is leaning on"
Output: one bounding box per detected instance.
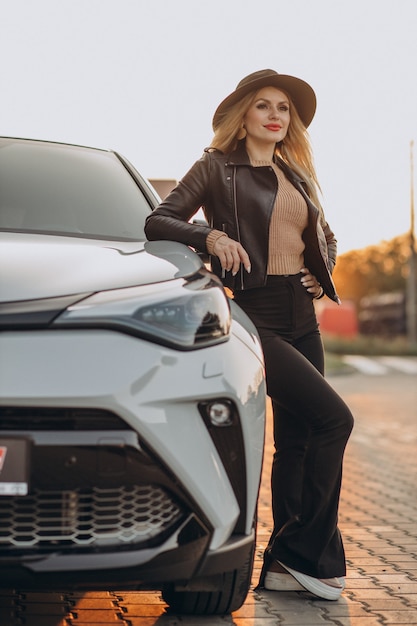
[0,138,265,614]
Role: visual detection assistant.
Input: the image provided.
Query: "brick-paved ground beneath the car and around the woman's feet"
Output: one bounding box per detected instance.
[0,374,417,626]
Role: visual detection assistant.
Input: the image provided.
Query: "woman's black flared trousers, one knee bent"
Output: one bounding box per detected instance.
[235,274,353,584]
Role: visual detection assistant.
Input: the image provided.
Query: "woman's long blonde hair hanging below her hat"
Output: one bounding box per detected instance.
[210,86,322,213]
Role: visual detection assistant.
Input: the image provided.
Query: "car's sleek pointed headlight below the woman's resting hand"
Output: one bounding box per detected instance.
[54,274,231,350]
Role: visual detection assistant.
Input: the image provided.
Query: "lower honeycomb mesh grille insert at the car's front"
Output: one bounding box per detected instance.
[0,485,184,553]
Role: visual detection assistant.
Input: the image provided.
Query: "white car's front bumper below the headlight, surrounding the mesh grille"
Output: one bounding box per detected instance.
[0,329,265,588]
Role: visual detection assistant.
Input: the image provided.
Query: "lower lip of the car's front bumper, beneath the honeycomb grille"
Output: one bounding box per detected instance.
[0,517,255,590]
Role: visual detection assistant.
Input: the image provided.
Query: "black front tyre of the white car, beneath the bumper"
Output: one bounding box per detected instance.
[162,542,255,615]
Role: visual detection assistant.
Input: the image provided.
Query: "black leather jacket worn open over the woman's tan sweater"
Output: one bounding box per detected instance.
[145,141,339,302]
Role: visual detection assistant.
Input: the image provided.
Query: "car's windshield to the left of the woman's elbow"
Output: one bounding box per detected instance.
[0,138,151,241]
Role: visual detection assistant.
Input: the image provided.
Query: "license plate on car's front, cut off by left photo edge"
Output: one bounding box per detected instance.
[0,437,30,496]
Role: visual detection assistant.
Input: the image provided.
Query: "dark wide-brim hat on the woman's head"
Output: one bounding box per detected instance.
[213,70,317,130]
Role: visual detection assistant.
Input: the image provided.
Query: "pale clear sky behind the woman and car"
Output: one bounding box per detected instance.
[0,0,417,253]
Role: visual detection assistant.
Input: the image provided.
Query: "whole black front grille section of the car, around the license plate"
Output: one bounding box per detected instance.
[0,407,194,556]
